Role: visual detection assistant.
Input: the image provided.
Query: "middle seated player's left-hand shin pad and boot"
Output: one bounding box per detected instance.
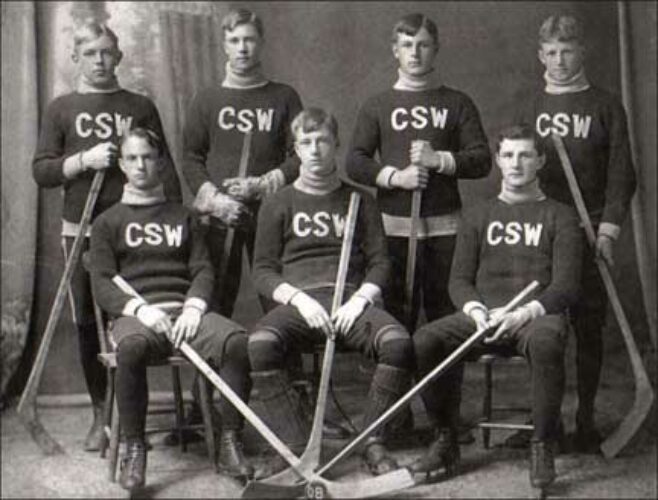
[251,370,309,479]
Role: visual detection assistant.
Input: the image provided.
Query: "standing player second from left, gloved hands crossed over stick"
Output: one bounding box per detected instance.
[183,9,301,317]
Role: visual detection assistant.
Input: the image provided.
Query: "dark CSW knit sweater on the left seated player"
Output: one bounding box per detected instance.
[91,202,214,316]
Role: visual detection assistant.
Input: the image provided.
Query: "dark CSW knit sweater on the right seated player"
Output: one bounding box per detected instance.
[449,198,583,314]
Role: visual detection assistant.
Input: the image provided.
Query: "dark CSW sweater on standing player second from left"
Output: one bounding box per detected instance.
[183,82,302,194]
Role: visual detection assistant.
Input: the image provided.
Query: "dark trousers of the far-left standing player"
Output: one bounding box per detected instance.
[62,236,107,406]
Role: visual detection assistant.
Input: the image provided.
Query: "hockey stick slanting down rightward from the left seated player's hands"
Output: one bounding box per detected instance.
[112,275,415,498]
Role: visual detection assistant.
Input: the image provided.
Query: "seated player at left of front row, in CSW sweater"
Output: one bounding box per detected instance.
[91,128,253,490]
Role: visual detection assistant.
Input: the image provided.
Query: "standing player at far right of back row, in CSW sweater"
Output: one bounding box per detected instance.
[521,16,636,452]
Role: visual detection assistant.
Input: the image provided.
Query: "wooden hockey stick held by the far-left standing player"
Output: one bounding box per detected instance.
[17,170,105,455]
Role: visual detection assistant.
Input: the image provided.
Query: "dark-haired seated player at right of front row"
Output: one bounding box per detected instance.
[411,125,582,487]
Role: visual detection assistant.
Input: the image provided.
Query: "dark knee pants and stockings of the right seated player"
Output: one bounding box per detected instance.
[413,312,568,440]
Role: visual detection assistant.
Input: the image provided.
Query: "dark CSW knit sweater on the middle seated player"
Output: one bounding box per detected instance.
[253,184,389,297]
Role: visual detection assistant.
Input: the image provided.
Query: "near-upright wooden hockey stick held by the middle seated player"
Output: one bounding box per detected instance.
[254,191,361,488]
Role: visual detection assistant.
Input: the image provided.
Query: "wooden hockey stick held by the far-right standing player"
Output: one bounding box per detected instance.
[552,133,654,458]
